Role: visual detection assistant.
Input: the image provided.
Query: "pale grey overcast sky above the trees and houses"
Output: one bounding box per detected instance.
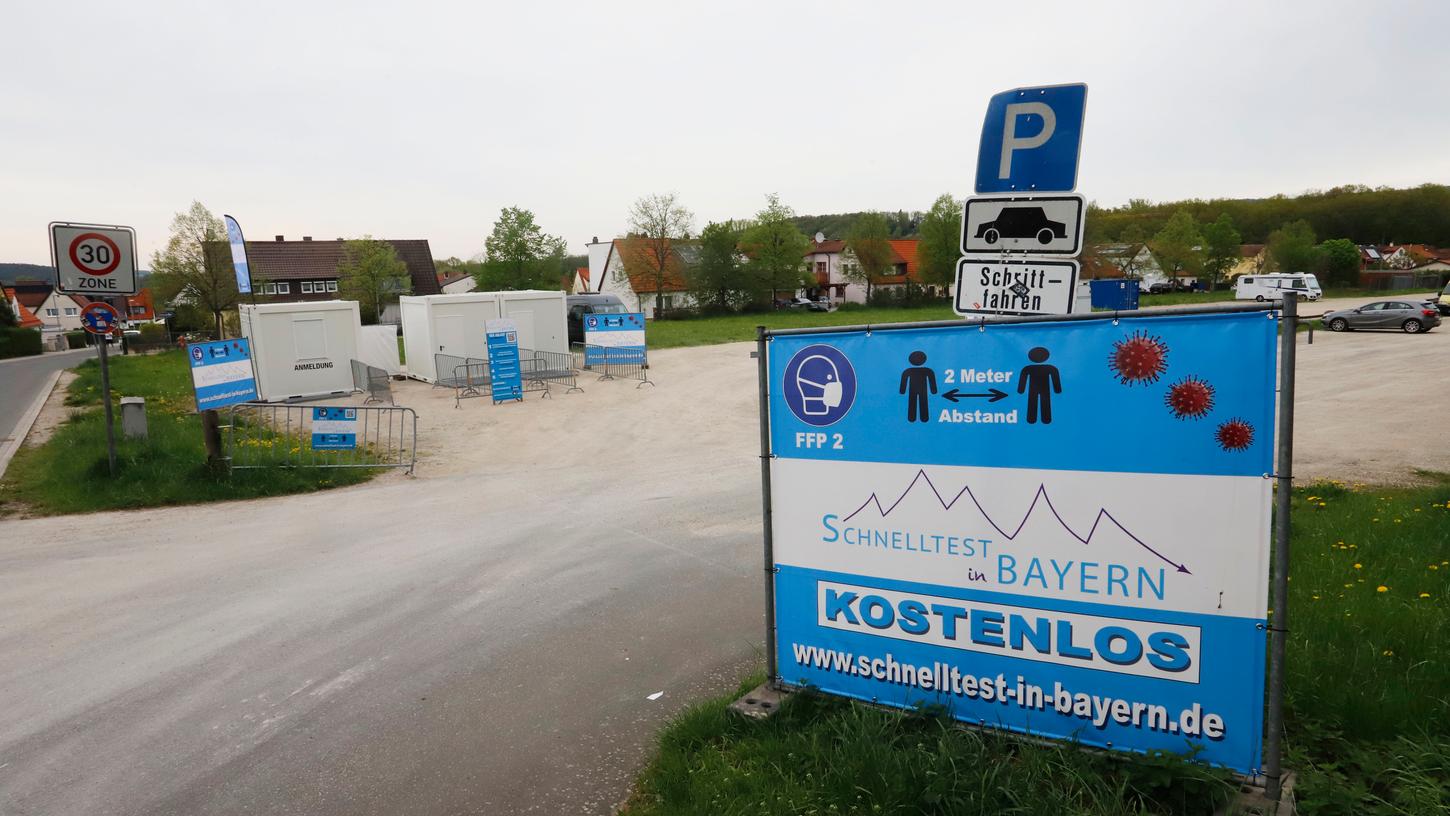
[0,0,1450,267]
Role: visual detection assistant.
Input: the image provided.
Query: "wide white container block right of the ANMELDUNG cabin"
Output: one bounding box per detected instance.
[399,290,568,383]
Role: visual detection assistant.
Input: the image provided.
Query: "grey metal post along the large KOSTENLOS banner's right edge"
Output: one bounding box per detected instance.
[1264,291,1299,802]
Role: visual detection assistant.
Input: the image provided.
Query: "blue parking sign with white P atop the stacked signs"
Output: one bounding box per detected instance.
[976,84,1088,193]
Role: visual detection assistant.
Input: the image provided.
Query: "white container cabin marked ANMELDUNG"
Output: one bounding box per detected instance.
[238,300,361,401]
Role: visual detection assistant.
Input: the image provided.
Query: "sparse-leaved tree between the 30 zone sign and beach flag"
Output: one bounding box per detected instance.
[151,201,241,338]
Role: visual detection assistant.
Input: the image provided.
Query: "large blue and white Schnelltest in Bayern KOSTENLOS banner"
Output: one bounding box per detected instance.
[769,312,1277,773]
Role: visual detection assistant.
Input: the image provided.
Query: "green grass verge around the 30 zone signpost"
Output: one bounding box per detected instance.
[0,351,373,515]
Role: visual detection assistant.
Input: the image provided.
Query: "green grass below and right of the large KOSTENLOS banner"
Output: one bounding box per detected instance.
[628,474,1450,816]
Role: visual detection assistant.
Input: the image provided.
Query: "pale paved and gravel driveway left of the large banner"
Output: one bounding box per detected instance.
[0,346,763,816]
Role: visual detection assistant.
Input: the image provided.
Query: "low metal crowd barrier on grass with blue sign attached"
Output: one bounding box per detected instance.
[222,403,418,472]
